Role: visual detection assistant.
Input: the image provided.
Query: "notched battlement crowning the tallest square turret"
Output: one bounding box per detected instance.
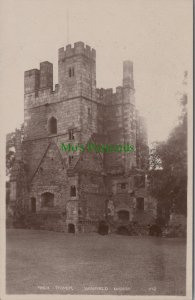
[58,42,96,61]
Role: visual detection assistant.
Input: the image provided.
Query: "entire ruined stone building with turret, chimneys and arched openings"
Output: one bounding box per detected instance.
[10,42,155,232]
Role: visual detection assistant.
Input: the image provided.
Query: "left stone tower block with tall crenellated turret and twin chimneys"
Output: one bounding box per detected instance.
[23,42,103,232]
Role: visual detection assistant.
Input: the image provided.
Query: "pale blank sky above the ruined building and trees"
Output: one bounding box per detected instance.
[0,0,193,143]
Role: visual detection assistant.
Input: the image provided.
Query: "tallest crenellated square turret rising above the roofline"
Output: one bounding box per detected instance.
[58,42,96,100]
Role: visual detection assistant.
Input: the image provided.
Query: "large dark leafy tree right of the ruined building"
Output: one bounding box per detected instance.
[149,72,187,220]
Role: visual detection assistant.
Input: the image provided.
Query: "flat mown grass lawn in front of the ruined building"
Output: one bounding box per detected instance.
[6,229,186,295]
